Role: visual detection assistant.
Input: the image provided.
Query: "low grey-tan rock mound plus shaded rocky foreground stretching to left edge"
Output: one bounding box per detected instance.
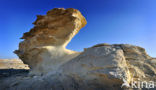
[1,44,156,90]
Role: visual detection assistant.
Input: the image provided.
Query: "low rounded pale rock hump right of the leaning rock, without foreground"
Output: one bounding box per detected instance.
[61,43,156,87]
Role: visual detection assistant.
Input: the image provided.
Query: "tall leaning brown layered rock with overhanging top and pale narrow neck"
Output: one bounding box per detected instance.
[15,8,87,72]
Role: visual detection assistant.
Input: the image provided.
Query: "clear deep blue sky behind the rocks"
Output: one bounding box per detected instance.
[0,0,156,58]
